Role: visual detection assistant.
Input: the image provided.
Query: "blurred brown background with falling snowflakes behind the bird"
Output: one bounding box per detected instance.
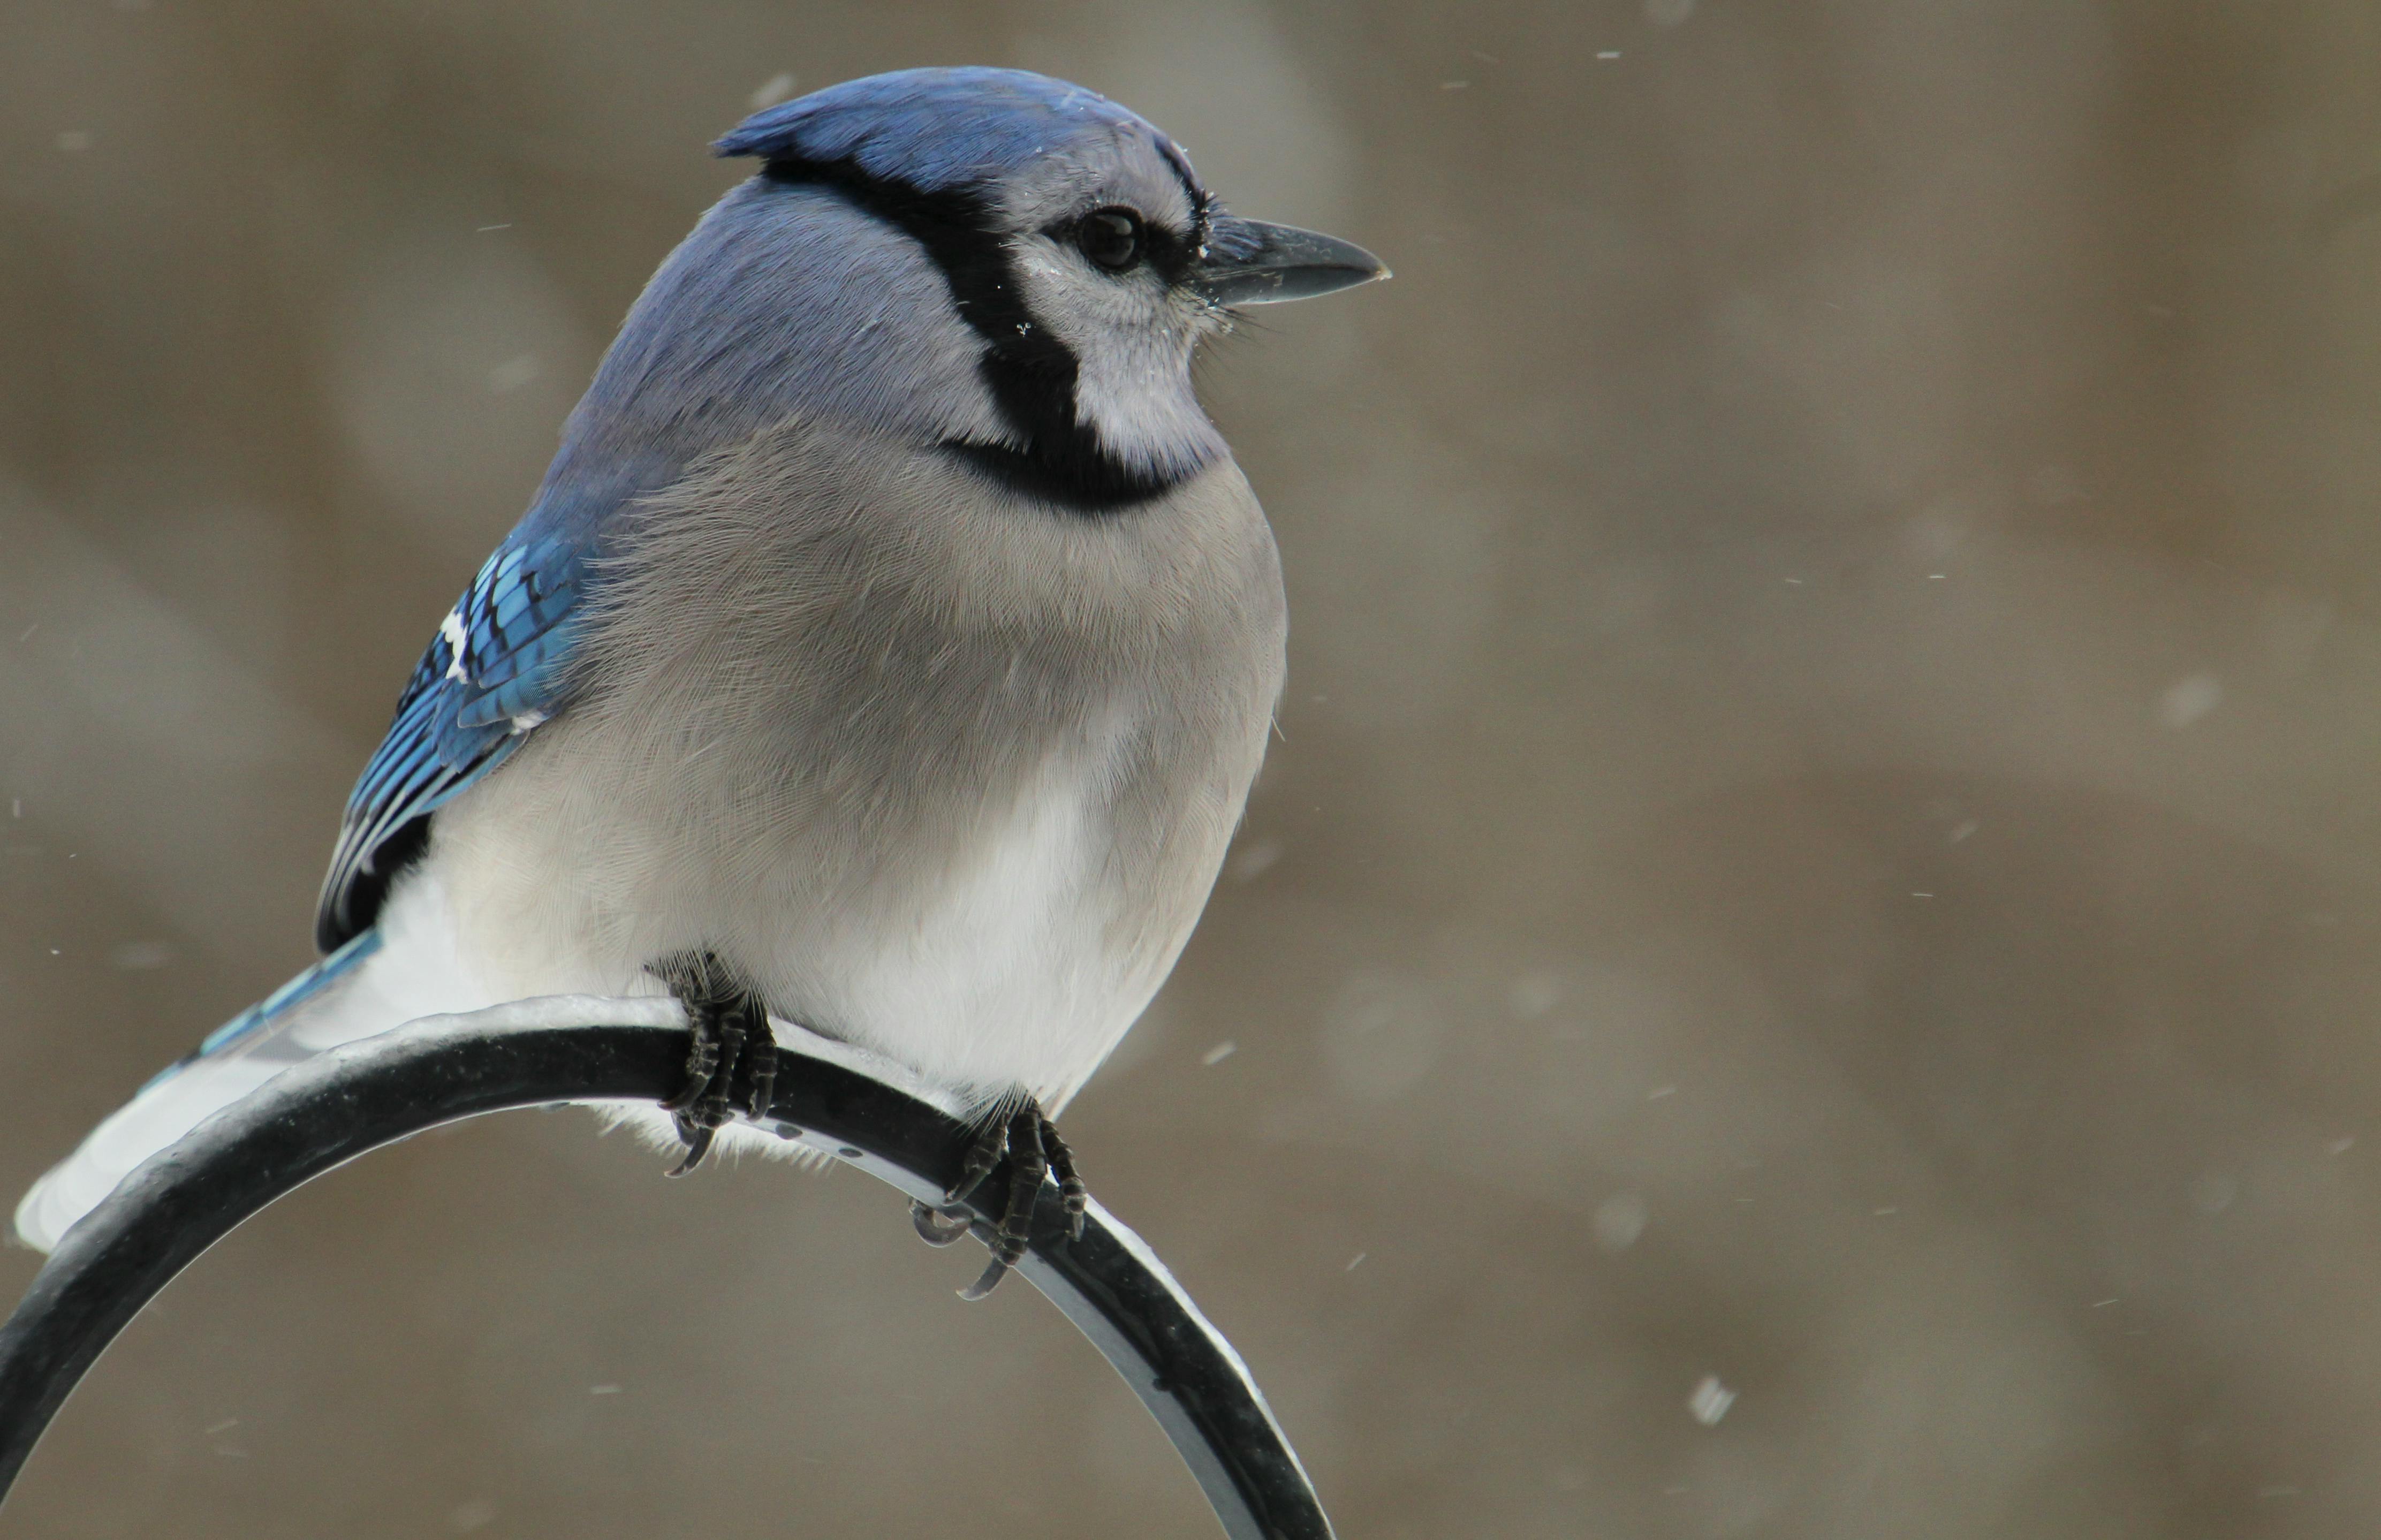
[0,0,2381,1540]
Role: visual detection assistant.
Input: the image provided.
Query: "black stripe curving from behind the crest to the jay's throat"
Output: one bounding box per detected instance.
[762,160,1181,514]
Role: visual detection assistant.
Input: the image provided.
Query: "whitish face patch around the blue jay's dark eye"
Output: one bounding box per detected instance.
[1003,133,1229,488]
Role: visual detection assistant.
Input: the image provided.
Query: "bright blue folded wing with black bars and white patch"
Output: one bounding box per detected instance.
[314,530,586,952]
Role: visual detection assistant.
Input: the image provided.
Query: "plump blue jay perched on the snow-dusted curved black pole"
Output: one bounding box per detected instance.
[17,69,1386,1293]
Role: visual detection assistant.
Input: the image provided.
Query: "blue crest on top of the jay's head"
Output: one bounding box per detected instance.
[712,67,1190,193]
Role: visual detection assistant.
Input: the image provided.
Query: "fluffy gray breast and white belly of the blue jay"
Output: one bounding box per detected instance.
[434,426,1283,1107]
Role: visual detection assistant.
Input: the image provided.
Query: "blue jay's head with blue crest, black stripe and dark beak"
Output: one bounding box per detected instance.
[576,69,1388,510]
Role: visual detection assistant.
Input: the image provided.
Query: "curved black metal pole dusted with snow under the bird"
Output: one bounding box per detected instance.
[0,1000,1331,1540]
